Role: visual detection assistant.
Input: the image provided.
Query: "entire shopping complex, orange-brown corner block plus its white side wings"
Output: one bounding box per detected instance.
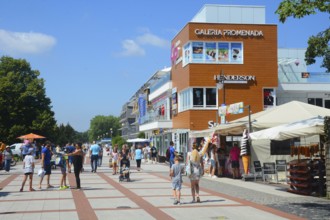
[122,5,330,158]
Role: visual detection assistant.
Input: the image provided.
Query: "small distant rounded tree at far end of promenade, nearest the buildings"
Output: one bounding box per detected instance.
[88,115,120,142]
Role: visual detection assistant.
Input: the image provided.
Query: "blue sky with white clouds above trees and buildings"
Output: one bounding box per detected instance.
[0,0,329,132]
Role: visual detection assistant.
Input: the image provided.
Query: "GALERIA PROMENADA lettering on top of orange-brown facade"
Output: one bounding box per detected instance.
[195,29,264,37]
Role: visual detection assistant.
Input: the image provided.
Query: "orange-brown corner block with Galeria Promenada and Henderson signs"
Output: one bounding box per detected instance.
[172,5,278,151]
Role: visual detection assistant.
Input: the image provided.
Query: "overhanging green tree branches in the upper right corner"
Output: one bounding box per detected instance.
[276,0,330,72]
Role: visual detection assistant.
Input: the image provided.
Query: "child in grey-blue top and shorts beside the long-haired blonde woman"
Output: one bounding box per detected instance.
[170,156,184,205]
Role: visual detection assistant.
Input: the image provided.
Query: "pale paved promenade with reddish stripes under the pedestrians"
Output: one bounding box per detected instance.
[0,154,330,220]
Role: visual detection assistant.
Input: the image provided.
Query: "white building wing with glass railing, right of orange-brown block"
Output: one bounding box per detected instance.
[276,48,330,109]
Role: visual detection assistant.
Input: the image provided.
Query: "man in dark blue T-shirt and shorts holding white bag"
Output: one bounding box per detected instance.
[39,141,53,189]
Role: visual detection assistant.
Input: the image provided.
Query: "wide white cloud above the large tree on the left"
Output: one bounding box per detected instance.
[0,29,56,55]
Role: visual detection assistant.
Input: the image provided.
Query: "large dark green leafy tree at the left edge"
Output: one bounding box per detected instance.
[0,56,56,144]
